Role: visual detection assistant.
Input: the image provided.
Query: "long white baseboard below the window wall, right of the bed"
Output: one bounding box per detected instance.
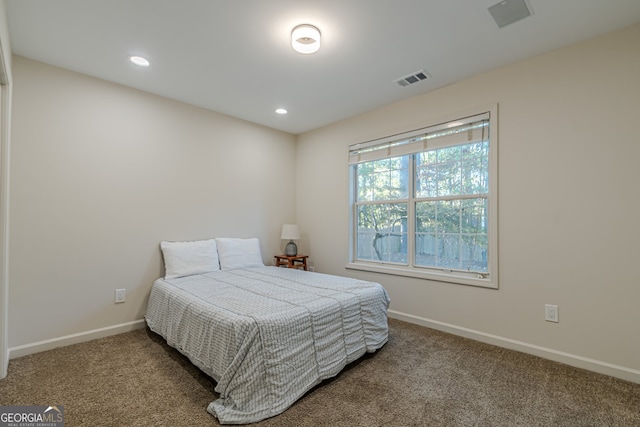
[389,310,640,384]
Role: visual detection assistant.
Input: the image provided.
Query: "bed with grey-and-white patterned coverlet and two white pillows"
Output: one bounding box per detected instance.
[145,239,390,424]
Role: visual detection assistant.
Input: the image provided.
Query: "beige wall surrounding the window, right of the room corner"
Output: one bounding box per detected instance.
[296,26,640,381]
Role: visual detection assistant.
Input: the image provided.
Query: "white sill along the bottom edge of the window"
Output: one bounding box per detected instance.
[345,262,498,289]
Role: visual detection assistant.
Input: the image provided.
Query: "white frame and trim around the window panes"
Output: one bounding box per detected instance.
[346,104,498,289]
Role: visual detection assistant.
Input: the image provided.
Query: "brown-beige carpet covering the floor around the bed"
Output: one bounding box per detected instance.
[0,320,640,427]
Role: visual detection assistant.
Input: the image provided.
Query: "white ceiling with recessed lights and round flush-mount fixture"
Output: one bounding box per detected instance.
[5,0,640,134]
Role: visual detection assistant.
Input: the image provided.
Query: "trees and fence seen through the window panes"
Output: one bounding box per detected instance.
[356,141,489,270]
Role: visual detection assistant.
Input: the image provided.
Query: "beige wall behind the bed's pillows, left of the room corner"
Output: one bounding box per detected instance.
[9,57,295,348]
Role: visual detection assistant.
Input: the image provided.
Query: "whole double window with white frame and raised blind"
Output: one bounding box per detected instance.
[347,107,498,288]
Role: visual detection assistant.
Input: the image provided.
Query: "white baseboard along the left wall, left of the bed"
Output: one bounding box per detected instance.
[9,319,146,359]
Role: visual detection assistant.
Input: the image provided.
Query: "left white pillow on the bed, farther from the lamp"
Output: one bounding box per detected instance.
[160,239,220,279]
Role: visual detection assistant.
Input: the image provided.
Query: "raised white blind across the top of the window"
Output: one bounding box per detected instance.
[349,112,490,165]
